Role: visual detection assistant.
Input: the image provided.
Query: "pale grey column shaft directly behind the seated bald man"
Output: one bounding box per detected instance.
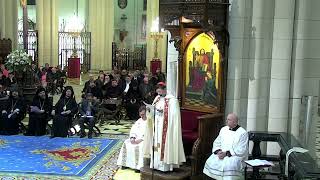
[225,0,248,128]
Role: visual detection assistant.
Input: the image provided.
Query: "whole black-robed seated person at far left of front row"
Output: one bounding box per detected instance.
[1,89,26,135]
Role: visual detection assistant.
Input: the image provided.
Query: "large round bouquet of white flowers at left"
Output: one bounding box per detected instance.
[5,50,31,71]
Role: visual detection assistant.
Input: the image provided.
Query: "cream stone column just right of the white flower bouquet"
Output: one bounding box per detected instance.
[36,0,59,66]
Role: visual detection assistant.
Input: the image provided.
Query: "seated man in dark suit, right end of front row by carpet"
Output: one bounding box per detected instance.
[79,93,97,139]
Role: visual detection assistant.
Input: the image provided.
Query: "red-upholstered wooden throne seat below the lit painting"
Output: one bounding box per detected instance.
[181,110,223,179]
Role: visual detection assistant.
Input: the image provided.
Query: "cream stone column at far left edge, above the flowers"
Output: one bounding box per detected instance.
[0,0,19,49]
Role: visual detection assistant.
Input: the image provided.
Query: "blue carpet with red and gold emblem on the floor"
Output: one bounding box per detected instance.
[0,136,122,179]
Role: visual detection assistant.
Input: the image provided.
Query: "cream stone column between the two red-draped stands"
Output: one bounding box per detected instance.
[88,0,114,70]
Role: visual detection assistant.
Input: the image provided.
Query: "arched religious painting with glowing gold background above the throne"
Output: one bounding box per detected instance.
[182,33,221,112]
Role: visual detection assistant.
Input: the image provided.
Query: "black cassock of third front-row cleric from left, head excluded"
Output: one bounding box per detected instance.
[52,97,78,137]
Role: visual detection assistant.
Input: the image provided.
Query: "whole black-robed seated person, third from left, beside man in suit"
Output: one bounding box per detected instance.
[51,86,78,138]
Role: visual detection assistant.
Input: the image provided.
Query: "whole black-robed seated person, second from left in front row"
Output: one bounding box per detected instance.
[26,88,52,136]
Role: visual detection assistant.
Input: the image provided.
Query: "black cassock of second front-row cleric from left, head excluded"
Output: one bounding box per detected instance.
[27,96,52,136]
